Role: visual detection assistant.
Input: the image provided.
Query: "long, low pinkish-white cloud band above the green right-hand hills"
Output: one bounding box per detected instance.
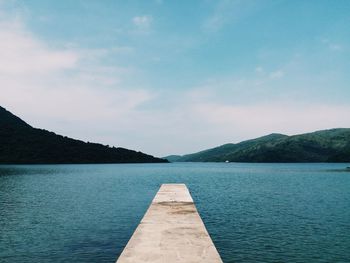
[194,101,350,135]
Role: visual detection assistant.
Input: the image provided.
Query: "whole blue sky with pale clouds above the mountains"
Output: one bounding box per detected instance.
[0,0,350,156]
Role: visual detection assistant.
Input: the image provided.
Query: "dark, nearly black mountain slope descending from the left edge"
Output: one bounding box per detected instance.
[0,107,168,164]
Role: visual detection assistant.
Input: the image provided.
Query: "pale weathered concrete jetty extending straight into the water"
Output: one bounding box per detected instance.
[117,184,222,263]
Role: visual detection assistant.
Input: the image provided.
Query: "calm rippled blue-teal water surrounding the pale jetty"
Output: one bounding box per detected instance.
[0,163,350,263]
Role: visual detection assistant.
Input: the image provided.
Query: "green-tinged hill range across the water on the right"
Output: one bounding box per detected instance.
[164,128,350,163]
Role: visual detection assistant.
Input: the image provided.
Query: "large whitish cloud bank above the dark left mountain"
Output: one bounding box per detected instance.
[0,17,151,151]
